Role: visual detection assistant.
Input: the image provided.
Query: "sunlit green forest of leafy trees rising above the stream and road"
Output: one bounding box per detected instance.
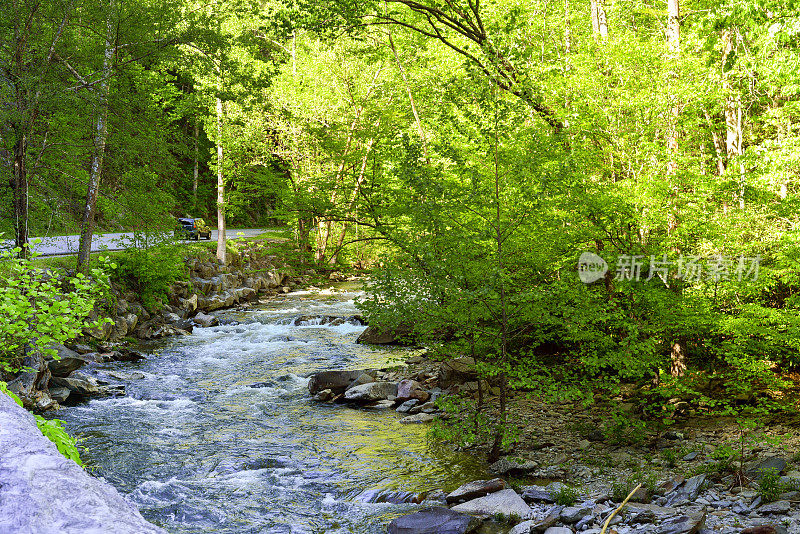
[0,0,800,506]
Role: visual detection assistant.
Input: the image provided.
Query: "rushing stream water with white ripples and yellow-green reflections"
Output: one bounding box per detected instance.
[59,285,486,534]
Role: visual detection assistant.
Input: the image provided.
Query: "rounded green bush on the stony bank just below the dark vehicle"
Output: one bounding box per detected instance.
[117,245,188,311]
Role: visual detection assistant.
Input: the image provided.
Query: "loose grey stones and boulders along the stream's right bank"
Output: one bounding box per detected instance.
[308,350,800,534]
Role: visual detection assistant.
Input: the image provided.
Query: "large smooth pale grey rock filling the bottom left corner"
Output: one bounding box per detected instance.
[0,394,165,534]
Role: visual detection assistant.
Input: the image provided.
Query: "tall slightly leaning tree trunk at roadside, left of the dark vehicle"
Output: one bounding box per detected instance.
[77,7,114,272]
